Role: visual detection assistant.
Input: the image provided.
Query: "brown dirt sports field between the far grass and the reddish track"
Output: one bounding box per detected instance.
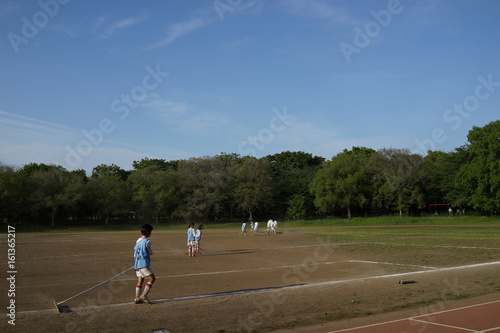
[0,229,500,333]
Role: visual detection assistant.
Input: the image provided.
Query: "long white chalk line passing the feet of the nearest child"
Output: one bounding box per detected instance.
[13,261,500,314]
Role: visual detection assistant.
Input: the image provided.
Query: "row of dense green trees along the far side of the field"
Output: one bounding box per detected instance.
[0,121,500,226]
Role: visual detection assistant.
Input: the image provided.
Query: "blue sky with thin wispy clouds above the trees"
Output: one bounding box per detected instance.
[0,0,500,172]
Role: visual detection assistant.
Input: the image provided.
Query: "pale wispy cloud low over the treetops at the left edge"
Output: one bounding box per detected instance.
[0,111,180,174]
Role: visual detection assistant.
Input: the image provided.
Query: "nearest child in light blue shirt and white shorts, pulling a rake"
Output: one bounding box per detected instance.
[134,224,156,304]
